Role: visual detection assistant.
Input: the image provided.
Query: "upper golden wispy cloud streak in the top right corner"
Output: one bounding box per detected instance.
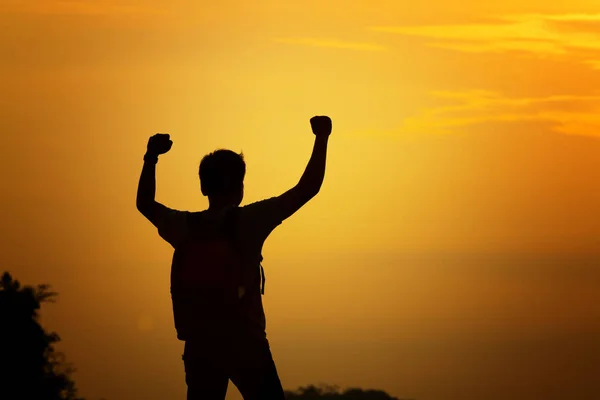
[370,14,600,61]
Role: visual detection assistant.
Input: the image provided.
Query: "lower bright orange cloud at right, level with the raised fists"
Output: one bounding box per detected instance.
[400,90,600,136]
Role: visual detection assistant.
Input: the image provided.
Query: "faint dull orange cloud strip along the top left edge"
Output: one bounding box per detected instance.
[0,0,166,17]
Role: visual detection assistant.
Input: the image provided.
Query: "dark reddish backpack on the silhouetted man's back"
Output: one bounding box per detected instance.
[171,207,264,341]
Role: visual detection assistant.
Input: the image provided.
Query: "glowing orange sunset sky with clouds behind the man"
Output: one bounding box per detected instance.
[0,0,600,400]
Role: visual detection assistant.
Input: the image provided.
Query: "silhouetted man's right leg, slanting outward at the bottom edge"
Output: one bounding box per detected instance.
[231,339,285,400]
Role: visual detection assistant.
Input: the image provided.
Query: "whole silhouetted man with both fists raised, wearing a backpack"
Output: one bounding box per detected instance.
[137,116,332,400]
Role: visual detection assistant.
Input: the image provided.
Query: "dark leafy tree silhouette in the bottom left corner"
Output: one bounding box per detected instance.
[0,272,83,400]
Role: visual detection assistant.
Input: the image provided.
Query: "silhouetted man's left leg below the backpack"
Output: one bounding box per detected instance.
[182,342,229,400]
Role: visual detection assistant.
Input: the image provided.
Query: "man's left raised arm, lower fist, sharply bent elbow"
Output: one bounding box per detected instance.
[136,133,173,226]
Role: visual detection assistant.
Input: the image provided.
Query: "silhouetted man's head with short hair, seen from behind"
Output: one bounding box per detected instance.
[198,149,246,196]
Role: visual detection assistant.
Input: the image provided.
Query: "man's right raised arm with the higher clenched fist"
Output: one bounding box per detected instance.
[278,116,331,220]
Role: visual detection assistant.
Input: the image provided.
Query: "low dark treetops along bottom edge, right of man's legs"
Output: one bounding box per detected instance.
[285,385,414,400]
